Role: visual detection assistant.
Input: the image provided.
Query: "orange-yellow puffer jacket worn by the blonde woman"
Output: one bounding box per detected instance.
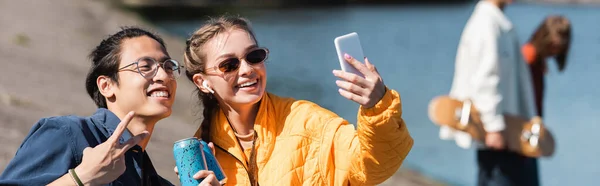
[195,89,413,185]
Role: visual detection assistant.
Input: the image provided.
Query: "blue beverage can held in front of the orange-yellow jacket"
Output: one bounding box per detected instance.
[173,137,210,186]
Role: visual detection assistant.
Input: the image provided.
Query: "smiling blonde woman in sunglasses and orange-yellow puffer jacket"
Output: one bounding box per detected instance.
[179,17,413,185]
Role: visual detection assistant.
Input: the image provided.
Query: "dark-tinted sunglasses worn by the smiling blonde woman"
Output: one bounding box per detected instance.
[208,48,269,73]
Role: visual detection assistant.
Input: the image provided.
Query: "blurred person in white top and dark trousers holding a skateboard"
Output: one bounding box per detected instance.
[440,0,539,186]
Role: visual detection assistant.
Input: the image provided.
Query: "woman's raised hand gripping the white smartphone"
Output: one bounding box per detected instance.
[333,54,385,108]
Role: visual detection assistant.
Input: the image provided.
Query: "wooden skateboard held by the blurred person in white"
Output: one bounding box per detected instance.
[429,96,555,158]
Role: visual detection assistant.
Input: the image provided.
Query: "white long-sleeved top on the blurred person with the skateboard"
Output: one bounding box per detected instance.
[440,0,535,148]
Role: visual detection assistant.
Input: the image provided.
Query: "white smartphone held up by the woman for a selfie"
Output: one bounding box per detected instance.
[333,32,365,78]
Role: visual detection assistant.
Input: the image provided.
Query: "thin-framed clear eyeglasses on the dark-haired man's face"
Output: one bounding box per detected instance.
[119,57,183,79]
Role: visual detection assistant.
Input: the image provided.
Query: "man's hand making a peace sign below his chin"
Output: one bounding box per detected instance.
[75,112,148,185]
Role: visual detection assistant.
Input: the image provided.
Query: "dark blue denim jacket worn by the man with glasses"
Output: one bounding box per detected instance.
[0,108,173,186]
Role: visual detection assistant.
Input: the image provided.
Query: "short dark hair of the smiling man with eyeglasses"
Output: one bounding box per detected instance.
[85,27,166,108]
